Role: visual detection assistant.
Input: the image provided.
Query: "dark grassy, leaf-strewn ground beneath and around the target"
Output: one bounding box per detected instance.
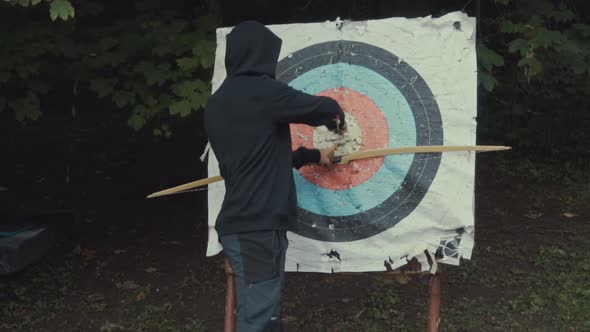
[0,156,590,332]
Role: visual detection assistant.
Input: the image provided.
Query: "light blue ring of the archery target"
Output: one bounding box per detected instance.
[289,62,416,217]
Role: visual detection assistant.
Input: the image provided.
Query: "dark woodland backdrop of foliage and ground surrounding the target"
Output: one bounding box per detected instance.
[0,0,590,331]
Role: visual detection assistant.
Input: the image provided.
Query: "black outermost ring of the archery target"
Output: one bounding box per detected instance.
[277,40,443,242]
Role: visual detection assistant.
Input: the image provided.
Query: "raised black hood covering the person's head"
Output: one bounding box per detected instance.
[225,21,283,78]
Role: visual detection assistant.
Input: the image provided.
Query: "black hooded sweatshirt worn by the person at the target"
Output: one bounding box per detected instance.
[205,21,344,236]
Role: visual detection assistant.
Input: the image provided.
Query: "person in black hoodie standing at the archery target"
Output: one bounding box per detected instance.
[205,21,346,332]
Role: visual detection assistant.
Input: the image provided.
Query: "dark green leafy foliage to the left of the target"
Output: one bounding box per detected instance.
[0,0,216,137]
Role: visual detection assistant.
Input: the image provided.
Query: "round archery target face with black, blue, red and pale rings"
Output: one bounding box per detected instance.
[277,41,443,242]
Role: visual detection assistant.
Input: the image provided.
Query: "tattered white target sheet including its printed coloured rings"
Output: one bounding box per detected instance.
[207,12,477,273]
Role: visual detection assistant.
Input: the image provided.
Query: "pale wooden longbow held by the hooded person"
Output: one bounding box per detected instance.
[147,145,510,198]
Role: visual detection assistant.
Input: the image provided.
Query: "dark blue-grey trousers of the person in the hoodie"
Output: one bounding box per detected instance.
[220,231,288,332]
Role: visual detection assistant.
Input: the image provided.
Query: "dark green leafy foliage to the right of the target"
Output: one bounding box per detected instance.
[478,0,590,158]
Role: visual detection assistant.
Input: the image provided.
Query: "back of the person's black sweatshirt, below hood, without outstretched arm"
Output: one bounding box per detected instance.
[205,76,295,234]
